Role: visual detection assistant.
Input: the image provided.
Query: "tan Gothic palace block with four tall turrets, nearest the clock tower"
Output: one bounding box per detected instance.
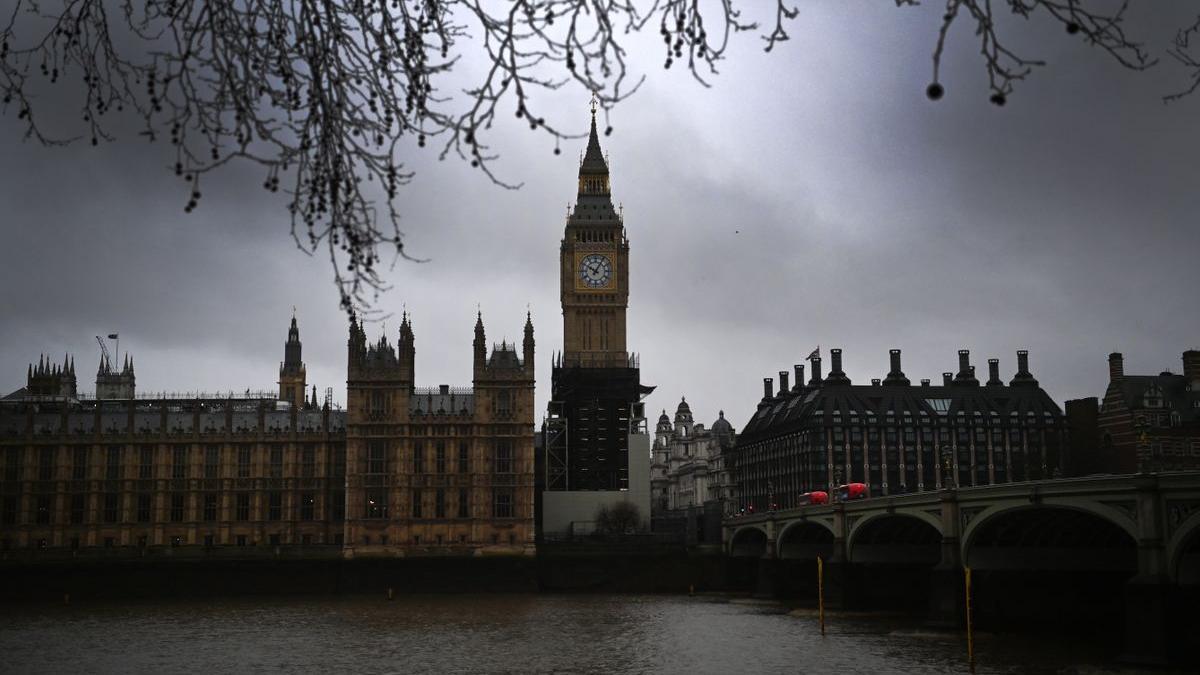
[346,316,534,555]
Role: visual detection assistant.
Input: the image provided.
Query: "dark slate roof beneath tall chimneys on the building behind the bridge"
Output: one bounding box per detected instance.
[739,384,1062,443]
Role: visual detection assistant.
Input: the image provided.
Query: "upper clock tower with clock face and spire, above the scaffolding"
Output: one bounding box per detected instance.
[559,96,629,368]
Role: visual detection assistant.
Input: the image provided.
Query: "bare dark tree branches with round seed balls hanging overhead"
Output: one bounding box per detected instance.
[0,0,1185,312]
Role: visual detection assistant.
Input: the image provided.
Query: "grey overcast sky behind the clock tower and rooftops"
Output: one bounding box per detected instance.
[0,0,1200,429]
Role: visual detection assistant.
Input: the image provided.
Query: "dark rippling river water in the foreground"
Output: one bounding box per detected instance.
[0,595,1180,675]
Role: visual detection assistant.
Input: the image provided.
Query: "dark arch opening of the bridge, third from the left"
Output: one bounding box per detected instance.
[846,510,942,566]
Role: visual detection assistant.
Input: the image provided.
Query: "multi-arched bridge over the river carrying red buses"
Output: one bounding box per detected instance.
[722,472,1200,662]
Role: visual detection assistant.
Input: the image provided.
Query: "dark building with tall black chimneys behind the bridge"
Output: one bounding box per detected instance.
[734,350,1067,513]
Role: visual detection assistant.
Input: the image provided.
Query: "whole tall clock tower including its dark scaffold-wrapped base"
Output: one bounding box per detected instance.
[539,97,654,502]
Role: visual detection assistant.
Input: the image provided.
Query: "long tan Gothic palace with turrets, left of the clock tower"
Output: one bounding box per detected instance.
[0,316,534,557]
